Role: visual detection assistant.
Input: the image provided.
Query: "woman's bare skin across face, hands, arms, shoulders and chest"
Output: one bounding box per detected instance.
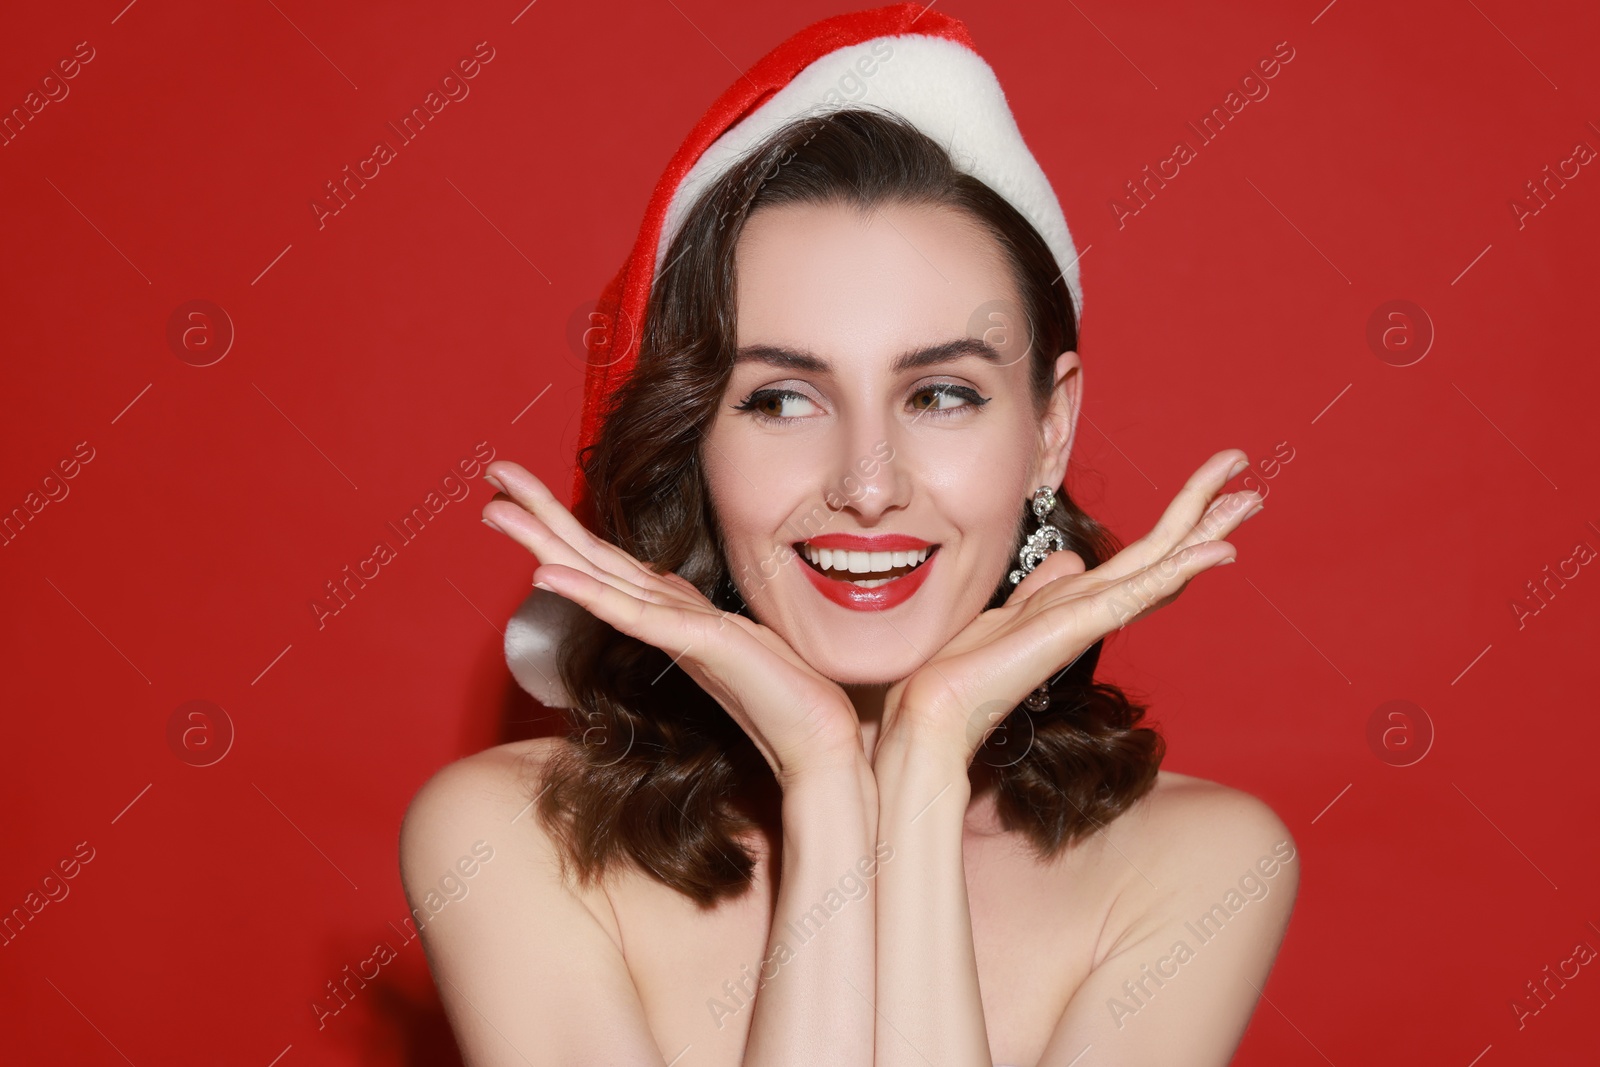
[402,205,1298,1067]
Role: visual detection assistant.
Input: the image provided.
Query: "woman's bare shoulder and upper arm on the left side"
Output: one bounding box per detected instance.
[400,739,661,1067]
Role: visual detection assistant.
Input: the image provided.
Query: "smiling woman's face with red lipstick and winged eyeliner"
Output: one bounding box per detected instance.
[701,205,1080,685]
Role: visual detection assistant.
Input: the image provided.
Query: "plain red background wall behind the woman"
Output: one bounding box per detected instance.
[0,0,1600,1067]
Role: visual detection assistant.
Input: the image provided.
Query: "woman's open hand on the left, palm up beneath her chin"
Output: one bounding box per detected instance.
[483,459,866,785]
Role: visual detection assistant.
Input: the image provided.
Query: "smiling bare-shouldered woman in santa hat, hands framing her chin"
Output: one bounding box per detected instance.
[402,5,1298,1067]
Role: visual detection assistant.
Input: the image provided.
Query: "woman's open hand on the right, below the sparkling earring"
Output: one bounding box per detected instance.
[877,450,1261,768]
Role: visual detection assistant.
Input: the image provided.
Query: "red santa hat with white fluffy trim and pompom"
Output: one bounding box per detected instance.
[506,3,1083,705]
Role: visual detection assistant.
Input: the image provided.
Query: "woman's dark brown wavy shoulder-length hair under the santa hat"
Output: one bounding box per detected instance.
[538,109,1165,907]
